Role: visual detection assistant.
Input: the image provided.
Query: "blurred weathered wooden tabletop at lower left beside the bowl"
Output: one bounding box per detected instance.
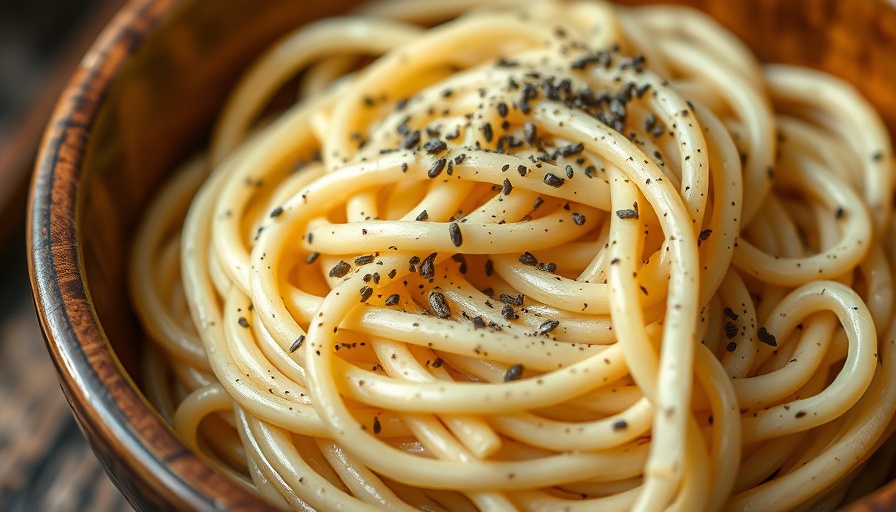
[0,226,131,512]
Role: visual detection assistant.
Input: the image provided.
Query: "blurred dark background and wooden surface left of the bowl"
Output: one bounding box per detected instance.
[0,0,130,512]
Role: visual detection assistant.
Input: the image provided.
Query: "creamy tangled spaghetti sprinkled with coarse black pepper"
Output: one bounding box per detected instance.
[130,1,896,511]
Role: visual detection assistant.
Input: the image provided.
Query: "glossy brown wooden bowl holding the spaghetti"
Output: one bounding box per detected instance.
[29,0,896,511]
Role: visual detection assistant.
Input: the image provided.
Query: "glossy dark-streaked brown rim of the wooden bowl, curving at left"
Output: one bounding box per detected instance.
[26,0,268,510]
